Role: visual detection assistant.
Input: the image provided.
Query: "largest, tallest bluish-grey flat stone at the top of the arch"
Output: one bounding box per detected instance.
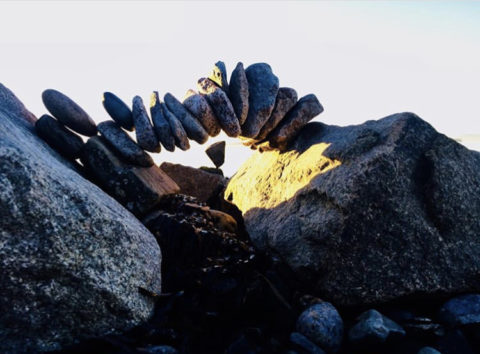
[242,63,278,138]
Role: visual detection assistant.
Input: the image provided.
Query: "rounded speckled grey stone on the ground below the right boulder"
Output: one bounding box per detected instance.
[297,302,343,353]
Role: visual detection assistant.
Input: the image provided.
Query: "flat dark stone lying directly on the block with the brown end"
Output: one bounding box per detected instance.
[98,120,153,167]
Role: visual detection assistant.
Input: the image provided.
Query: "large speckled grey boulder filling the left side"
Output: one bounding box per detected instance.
[0,86,161,353]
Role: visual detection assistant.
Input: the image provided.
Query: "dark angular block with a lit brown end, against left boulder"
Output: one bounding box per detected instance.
[81,137,179,215]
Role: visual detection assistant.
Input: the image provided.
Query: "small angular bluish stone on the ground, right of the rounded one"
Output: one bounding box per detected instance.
[348,310,405,344]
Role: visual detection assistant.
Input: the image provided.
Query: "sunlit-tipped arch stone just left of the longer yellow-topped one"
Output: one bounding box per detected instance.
[183,90,221,136]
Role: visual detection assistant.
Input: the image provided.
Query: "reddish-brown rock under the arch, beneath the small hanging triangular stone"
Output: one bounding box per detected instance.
[160,162,227,202]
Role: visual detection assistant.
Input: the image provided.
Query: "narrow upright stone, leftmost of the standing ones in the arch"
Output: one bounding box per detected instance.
[132,96,160,152]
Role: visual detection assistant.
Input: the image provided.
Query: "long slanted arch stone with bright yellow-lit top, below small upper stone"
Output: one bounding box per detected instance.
[198,78,241,137]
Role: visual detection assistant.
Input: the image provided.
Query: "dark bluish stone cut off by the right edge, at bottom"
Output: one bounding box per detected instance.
[438,294,480,327]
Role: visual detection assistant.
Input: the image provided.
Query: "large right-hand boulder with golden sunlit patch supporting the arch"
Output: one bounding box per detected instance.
[225,113,480,306]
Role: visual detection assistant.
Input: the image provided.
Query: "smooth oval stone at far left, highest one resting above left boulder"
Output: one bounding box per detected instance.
[42,89,97,136]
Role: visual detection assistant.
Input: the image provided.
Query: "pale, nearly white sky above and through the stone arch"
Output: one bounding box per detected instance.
[0,0,480,175]
